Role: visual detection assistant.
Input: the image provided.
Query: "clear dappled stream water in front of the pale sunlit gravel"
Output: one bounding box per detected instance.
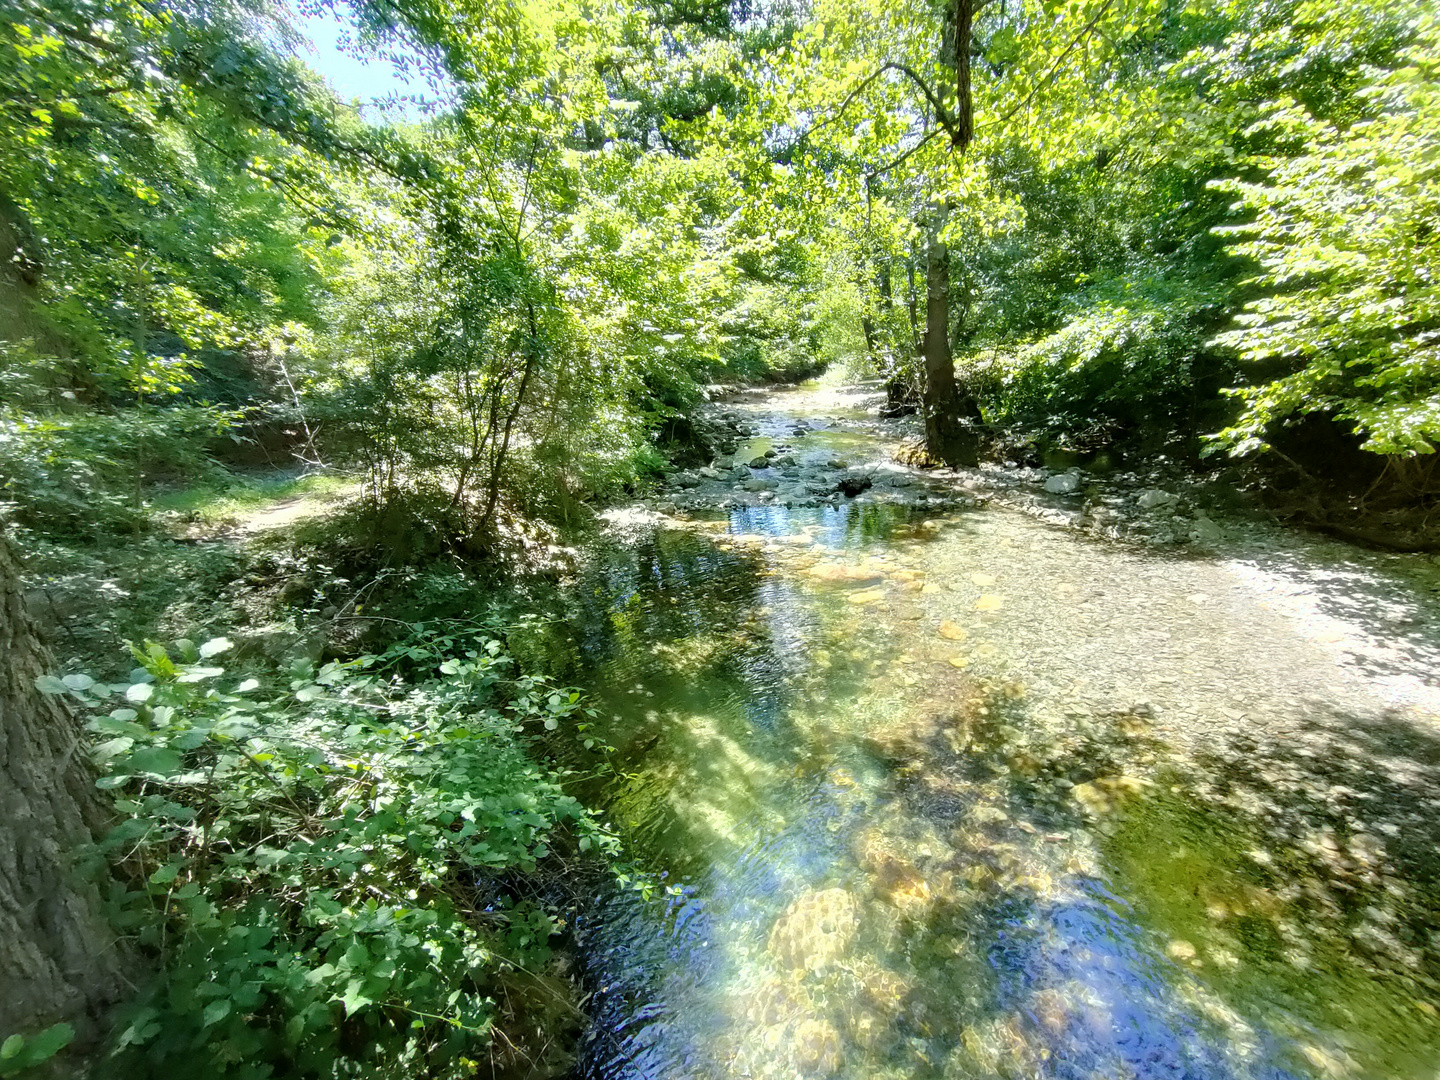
[544,505,1440,1080]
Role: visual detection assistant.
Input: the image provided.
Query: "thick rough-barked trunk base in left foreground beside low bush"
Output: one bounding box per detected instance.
[0,526,125,1048]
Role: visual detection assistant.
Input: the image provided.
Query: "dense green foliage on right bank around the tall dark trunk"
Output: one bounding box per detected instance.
[755,0,1436,472]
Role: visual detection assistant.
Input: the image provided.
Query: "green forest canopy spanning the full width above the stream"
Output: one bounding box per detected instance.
[0,0,1440,550]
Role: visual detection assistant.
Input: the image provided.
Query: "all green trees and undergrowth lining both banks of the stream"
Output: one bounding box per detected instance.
[0,0,1440,1076]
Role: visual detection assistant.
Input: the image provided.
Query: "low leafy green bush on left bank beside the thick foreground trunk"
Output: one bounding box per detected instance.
[37,632,616,1079]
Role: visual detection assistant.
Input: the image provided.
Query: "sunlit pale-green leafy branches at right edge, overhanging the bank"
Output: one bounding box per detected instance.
[1218,10,1440,454]
